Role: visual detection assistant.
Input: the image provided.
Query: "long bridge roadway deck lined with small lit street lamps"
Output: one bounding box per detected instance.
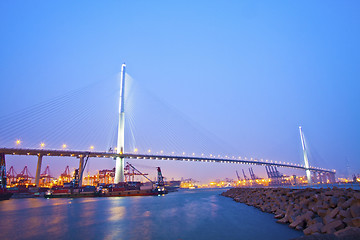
[0,148,335,174]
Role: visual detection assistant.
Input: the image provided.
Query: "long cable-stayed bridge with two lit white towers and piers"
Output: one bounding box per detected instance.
[0,65,335,186]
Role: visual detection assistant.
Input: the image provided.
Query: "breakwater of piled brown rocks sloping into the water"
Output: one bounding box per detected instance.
[222,188,360,239]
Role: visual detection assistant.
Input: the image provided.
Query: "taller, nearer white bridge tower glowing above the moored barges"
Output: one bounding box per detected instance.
[114,63,126,183]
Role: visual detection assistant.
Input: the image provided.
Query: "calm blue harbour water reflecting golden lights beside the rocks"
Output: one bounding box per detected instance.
[0,190,302,240]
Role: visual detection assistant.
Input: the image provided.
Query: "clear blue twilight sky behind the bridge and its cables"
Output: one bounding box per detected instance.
[0,1,360,181]
